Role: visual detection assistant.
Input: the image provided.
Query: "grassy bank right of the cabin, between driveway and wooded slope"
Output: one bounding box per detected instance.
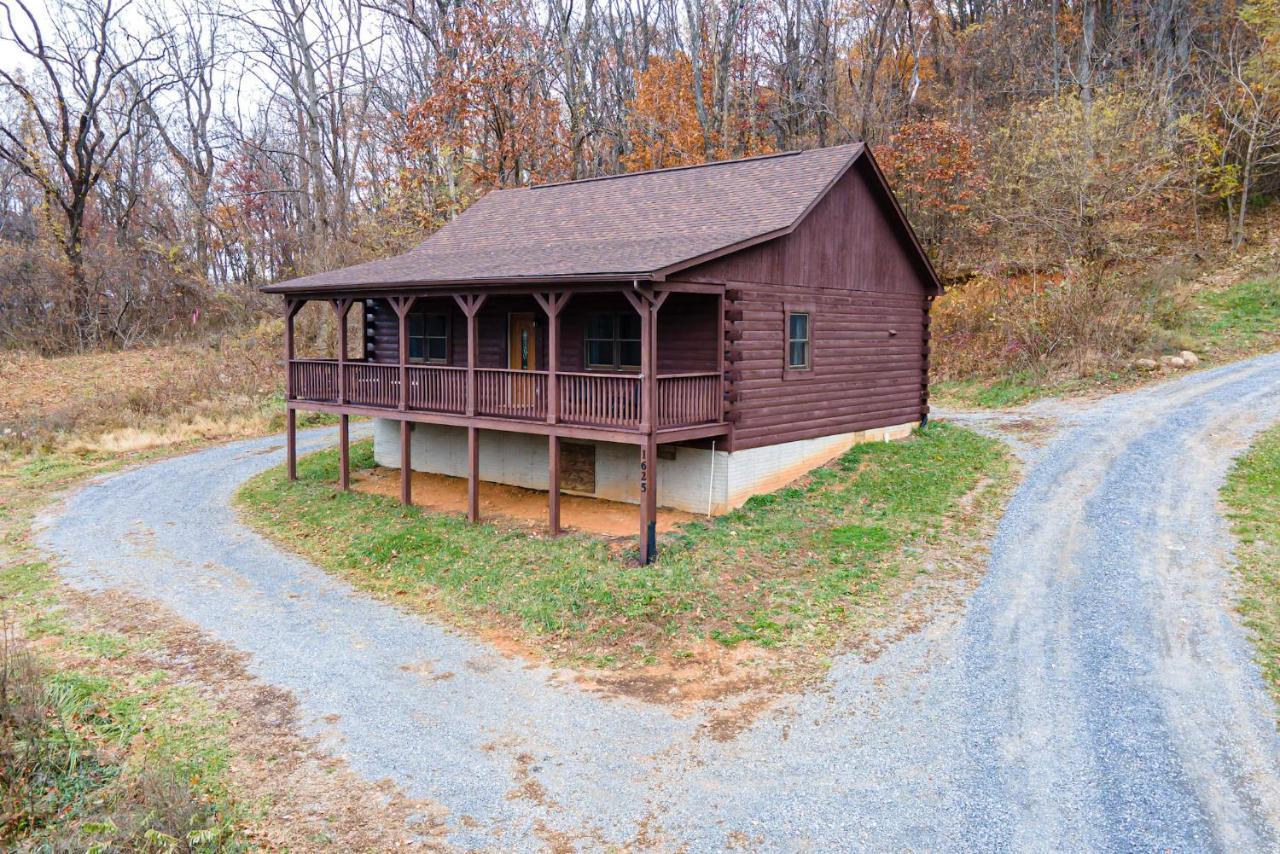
[932,275,1280,408]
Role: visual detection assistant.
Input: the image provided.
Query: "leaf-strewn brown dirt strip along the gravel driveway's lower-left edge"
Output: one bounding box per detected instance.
[61,588,448,850]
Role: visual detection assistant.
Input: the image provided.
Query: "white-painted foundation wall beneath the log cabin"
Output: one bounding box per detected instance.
[374,419,918,515]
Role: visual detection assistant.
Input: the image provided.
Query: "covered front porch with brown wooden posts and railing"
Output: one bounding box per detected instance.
[285,283,728,562]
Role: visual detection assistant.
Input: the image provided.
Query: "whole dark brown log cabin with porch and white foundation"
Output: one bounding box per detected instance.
[264,143,942,562]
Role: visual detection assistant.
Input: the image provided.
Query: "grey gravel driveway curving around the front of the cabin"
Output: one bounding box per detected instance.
[41,355,1280,850]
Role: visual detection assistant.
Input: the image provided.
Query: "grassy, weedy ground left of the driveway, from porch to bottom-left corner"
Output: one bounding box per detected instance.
[0,330,340,850]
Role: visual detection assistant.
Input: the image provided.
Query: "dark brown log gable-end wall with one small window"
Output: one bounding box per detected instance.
[680,161,929,449]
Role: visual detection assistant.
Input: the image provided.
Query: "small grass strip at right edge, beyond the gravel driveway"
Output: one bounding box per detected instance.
[1222,425,1280,704]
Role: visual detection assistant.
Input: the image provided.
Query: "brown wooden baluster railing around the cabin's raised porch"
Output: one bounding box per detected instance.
[288,359,723,430]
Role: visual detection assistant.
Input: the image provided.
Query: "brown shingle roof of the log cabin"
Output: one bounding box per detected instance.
[264,143,863,292]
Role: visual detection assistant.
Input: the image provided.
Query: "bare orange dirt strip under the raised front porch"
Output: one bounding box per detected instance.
[352,467,699,536]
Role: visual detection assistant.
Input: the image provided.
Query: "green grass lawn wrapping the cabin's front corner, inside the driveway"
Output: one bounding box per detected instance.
[238,424,1012,666]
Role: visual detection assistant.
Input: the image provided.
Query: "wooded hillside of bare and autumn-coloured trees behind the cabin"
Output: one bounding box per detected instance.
[0,0,1280,371]
